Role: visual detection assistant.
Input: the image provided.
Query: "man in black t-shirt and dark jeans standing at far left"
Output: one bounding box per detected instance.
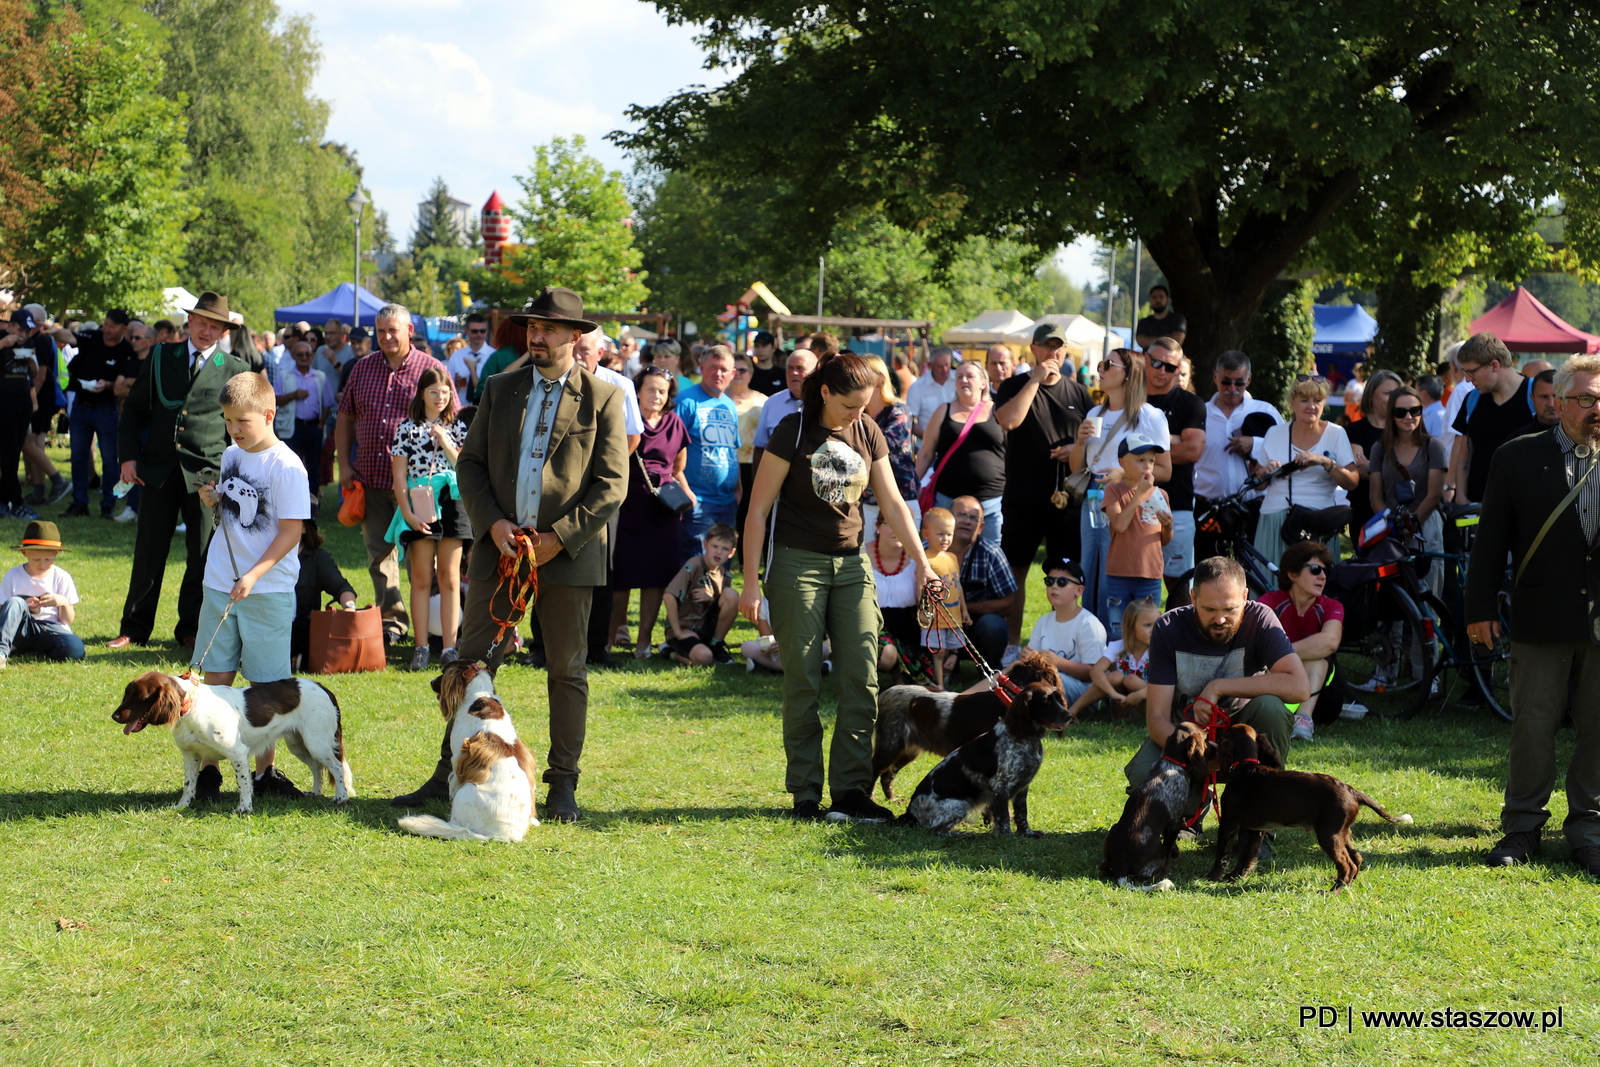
[64,307,138,518]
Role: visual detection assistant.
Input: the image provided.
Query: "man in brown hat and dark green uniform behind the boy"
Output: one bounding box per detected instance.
[106,293,262,646]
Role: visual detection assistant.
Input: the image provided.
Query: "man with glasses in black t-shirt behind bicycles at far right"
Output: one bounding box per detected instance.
[1445,333,1538,502]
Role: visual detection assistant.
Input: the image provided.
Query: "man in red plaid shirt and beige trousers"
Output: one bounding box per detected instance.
[334,304,448,645]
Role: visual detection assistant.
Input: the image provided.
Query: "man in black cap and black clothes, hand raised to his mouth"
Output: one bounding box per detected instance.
[995,323,1091,662]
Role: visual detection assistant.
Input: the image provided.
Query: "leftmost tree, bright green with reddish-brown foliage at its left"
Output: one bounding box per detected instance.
[0,0,189,317]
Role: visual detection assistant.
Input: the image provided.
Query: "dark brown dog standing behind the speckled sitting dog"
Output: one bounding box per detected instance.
[872,651,1061,800]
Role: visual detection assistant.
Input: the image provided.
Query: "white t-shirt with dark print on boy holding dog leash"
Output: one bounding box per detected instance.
[202,442,310,593]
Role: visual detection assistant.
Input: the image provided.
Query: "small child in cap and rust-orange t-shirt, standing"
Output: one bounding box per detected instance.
[1104,434,1173,638]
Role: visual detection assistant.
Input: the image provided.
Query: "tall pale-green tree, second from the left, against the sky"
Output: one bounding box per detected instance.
[147,0,360,320]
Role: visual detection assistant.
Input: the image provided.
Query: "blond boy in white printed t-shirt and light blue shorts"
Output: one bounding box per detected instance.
[195,371,310,800]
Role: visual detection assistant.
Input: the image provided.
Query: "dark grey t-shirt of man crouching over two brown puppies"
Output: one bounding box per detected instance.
[1146,600,1294,717]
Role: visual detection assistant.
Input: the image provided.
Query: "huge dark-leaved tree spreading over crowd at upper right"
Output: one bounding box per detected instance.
[614,0,1600,381]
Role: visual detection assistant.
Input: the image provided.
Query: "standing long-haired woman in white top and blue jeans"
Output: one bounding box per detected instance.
[1069,349,1173,621]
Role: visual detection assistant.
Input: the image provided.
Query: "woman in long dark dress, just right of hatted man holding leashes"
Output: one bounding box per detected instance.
[611,366,694,659]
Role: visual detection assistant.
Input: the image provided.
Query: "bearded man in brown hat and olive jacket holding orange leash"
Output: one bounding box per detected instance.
[392,286,627,822]
